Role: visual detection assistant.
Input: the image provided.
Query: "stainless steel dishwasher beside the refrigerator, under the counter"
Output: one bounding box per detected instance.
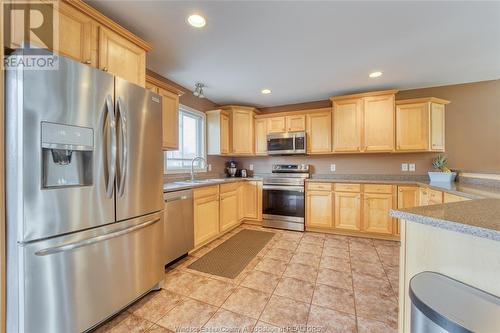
[163,190,194,265]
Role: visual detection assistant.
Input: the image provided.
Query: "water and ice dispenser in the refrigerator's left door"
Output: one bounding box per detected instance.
[41,122,94,188]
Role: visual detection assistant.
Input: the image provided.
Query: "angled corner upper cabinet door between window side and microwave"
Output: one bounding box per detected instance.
[231,109,254,155]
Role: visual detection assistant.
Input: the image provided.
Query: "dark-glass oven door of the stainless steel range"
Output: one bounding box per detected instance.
[262,185,304,223]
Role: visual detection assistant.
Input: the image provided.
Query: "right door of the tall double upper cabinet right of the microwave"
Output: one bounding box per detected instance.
[363,95,394,152]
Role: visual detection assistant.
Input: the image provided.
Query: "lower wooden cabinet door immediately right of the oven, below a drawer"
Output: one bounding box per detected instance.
[306,191,333,229]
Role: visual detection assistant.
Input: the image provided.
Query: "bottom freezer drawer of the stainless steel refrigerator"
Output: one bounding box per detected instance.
[15,212,164,332]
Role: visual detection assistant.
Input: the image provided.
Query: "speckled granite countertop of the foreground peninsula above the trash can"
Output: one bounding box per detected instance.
[390,199,500,241]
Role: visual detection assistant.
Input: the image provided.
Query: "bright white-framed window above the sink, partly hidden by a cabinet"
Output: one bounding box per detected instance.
[165,105,207,173]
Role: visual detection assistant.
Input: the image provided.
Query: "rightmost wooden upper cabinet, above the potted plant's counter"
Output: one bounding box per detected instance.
[396,97,449,151]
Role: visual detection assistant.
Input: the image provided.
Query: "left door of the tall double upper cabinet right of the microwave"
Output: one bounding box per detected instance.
[333,99,363,152]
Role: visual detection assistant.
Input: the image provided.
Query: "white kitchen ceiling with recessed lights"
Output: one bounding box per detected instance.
[88,0,500,106]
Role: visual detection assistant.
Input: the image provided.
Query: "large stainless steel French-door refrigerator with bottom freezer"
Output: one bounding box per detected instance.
[6,50,164,333]
